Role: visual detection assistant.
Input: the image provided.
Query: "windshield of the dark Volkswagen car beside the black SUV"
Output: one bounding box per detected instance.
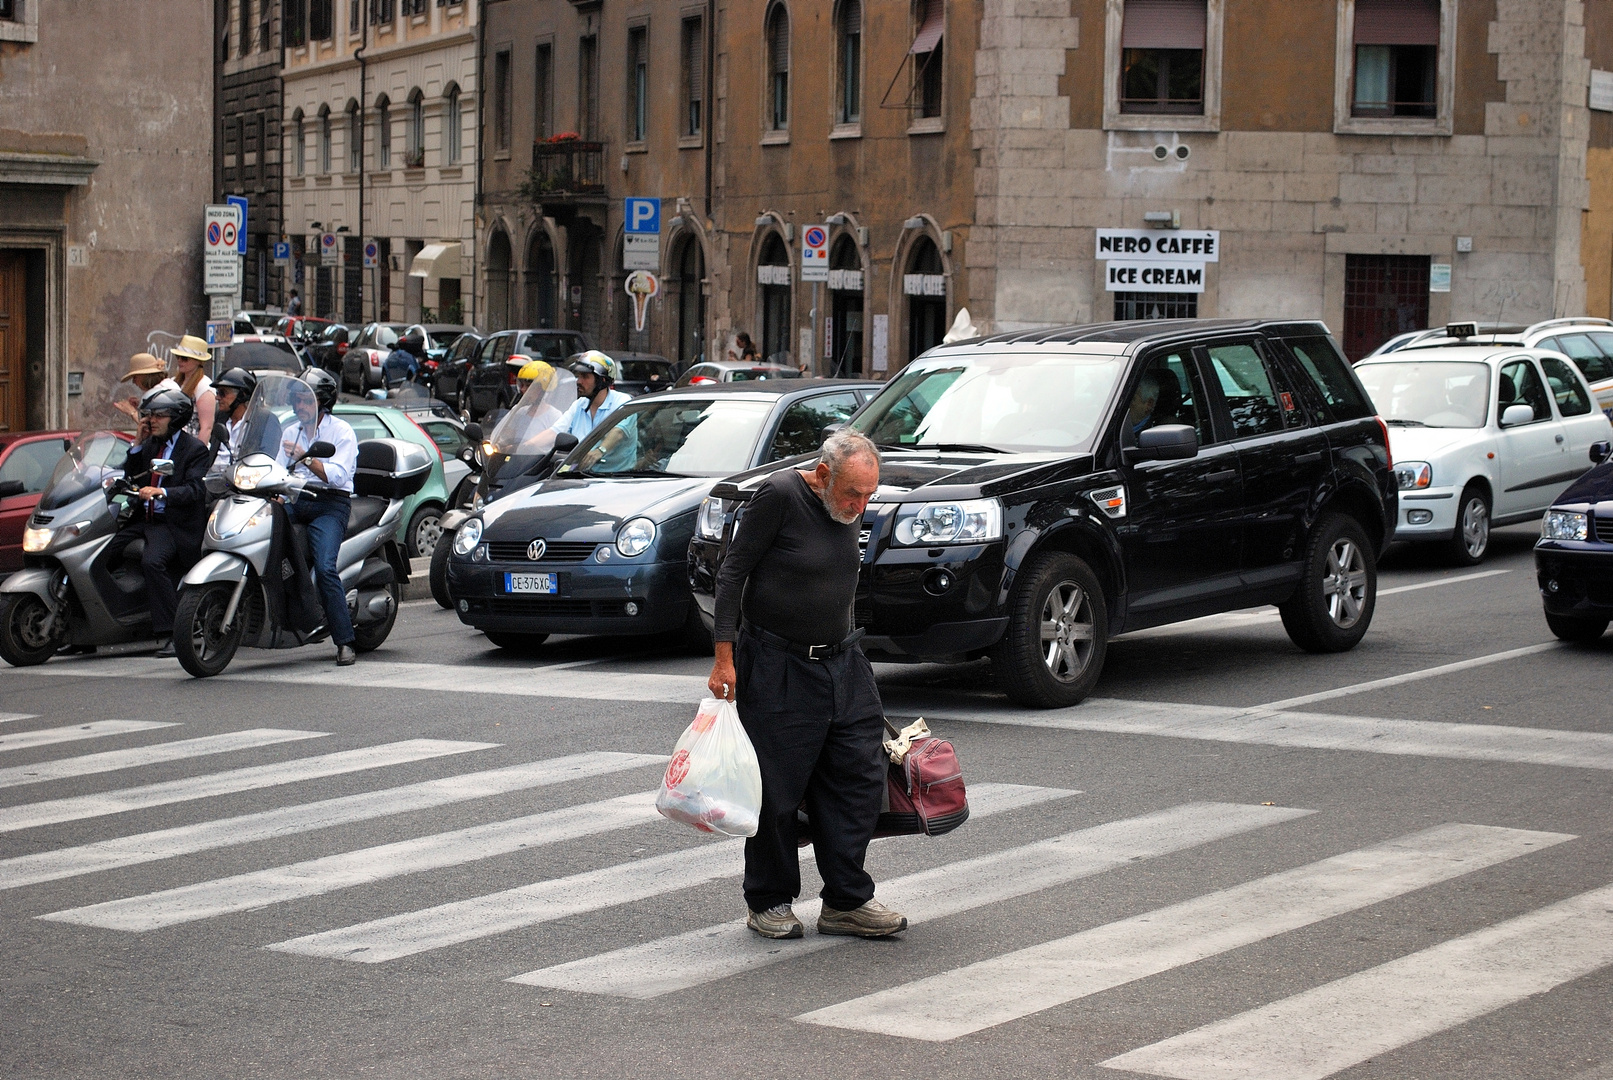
[560,398,773,476]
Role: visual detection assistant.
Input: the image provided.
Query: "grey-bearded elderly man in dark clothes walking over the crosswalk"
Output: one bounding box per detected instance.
[710,430,907,938]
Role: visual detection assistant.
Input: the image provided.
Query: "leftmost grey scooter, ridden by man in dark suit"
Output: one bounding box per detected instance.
[0,432,163,667]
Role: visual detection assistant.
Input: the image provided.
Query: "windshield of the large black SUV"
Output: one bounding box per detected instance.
[853,353,1124,453]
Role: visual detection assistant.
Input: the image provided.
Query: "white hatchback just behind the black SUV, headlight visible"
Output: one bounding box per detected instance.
[1355,342,1613,564]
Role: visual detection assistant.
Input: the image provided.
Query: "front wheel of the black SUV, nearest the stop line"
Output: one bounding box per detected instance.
[992,551,1108,709]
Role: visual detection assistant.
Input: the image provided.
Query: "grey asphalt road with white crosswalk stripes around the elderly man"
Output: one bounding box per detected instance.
[0,527,1613,1080]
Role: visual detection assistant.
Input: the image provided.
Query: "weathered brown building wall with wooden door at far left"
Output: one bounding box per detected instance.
[0,0,213,430]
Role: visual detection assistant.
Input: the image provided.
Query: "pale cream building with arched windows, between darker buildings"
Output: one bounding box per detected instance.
[281,0,479,324]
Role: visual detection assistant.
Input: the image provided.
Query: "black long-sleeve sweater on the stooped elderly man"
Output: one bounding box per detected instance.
[715,469,863,645]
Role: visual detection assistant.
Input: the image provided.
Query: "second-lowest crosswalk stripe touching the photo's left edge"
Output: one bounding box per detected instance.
[0,738,497,832]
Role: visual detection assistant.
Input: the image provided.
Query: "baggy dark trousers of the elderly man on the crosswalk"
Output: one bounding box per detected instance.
[734,630,886,911]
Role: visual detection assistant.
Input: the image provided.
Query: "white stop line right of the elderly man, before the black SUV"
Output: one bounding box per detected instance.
[926,698,1613,769]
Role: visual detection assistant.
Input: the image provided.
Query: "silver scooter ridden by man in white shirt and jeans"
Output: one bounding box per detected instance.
[174,376,431,679]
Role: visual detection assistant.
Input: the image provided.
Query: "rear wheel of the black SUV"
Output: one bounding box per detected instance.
[1277,514,1378,653]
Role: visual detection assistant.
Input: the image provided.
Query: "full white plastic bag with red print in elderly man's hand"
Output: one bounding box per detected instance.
[655,698,761,837]
